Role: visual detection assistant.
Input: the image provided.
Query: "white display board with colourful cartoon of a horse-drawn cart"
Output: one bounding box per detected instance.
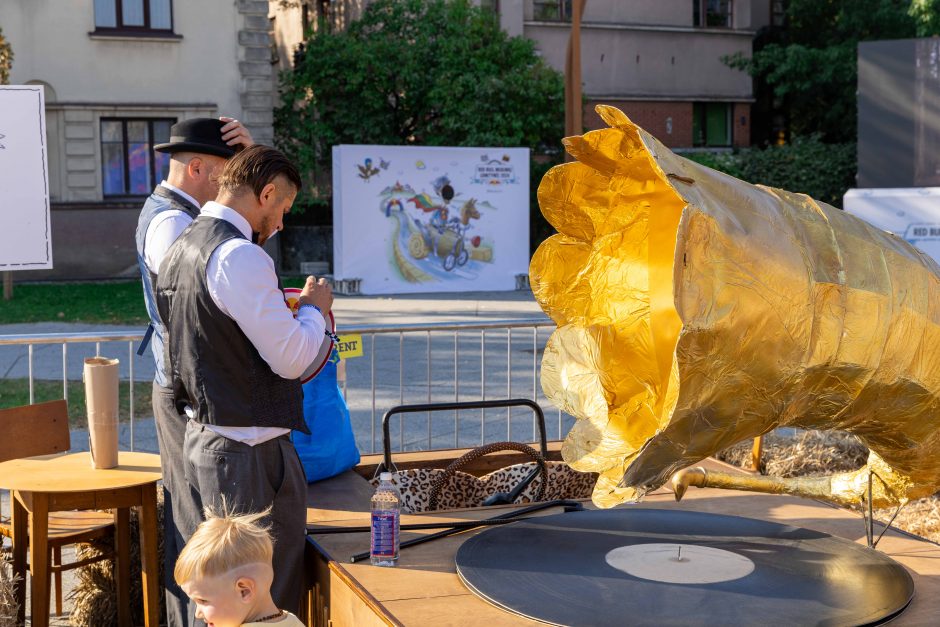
[333,145,529,294]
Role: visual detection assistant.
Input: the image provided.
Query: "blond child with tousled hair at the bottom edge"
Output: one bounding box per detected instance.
[173,511,303,627]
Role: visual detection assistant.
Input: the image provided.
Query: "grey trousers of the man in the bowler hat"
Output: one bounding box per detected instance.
[153,383,202,627]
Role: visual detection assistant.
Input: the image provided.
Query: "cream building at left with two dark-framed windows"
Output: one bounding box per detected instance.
[0,0,276,280]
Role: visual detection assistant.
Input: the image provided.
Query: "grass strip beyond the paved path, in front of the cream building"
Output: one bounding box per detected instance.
[0,277,304,330]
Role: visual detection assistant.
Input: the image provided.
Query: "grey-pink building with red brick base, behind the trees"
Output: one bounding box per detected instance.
[272,0,784,149]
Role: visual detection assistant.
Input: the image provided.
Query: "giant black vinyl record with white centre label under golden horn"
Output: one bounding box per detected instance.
[457,507,914,627]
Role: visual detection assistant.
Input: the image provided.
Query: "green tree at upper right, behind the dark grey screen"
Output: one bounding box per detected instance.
[726,0,940,142]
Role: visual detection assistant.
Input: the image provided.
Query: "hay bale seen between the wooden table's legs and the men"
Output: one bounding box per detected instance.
[69,490,166,625]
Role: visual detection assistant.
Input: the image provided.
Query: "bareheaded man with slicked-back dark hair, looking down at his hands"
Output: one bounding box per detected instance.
[155,146,333,613]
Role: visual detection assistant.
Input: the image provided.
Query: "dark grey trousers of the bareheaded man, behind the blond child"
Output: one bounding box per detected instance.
[179,420,307,616]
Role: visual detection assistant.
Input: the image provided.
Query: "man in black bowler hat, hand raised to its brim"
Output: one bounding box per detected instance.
[137,117,254,627]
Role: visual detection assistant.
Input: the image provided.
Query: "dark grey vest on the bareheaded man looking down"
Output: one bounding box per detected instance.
[155,216,310,433]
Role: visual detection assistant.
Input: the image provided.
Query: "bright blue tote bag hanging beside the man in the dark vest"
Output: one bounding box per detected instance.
[291,349,359,483]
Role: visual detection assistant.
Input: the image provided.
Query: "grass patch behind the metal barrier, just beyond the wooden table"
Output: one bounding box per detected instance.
[0,379,153,429]
